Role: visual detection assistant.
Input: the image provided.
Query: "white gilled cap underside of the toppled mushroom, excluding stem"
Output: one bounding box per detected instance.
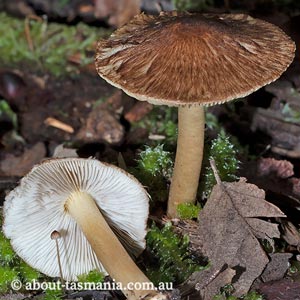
[3,158,149,280]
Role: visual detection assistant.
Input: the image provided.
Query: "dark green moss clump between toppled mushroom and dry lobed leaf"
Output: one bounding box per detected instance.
[146,223,203,284]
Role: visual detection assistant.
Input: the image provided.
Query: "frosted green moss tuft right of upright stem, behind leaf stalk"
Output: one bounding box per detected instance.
[202,130,240,198]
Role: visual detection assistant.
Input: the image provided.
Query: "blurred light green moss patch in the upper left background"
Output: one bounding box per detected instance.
[0,13,110,76]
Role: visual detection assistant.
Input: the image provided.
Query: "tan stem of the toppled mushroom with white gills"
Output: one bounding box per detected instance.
[65,192,162,300]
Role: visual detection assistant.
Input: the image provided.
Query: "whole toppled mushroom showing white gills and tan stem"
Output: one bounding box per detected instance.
[3,158,163,299]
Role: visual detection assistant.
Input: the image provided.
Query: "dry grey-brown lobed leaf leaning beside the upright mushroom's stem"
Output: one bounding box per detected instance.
[180,178,285,300]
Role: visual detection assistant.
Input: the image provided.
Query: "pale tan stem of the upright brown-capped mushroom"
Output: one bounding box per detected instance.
[167,105,205,218]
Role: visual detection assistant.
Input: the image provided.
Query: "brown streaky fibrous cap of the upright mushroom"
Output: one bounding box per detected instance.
[95,11,295,106]
